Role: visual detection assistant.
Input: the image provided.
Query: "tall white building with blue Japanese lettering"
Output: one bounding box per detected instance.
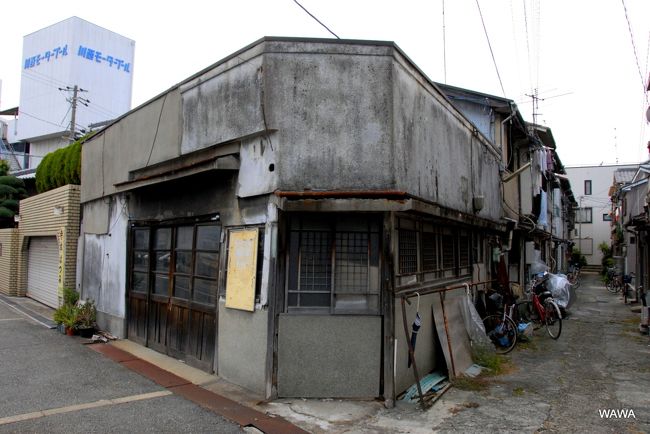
[2,17,135,171]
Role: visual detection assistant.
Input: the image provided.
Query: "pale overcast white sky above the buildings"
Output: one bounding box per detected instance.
[0,0,650,165]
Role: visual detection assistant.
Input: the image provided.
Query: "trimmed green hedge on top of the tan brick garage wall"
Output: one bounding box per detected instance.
[36,137,85,193]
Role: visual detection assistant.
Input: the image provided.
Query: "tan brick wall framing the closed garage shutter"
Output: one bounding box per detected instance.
[18,184,80,294]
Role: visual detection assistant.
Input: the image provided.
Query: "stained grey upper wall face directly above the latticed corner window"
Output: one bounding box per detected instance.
[264,42,394,191]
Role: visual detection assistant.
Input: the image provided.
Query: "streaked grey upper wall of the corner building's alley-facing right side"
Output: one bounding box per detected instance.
[392,56,501,220]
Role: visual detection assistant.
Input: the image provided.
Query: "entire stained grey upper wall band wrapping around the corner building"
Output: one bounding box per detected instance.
[82,40,501,227]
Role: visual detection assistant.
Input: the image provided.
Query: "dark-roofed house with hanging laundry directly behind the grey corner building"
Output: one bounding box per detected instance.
[438,84,575,282]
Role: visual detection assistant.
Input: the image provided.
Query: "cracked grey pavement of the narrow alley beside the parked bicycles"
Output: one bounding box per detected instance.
[262,273,650,433]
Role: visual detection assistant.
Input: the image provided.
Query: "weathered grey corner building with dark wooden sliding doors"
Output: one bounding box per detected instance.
[78,37,572,403]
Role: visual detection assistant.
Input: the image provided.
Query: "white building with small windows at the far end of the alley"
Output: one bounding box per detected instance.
[566,164,638,267]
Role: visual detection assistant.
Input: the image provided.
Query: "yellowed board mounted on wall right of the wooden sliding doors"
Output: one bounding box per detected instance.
[226,228,259,312]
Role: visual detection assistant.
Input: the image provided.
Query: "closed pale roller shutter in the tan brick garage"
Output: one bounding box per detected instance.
[27,237,59,308]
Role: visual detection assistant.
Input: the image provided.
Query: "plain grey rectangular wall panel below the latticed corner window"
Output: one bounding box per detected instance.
[278,315,382,398]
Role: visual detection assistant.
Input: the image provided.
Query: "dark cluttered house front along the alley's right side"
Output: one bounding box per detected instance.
[610,162,650,288]
